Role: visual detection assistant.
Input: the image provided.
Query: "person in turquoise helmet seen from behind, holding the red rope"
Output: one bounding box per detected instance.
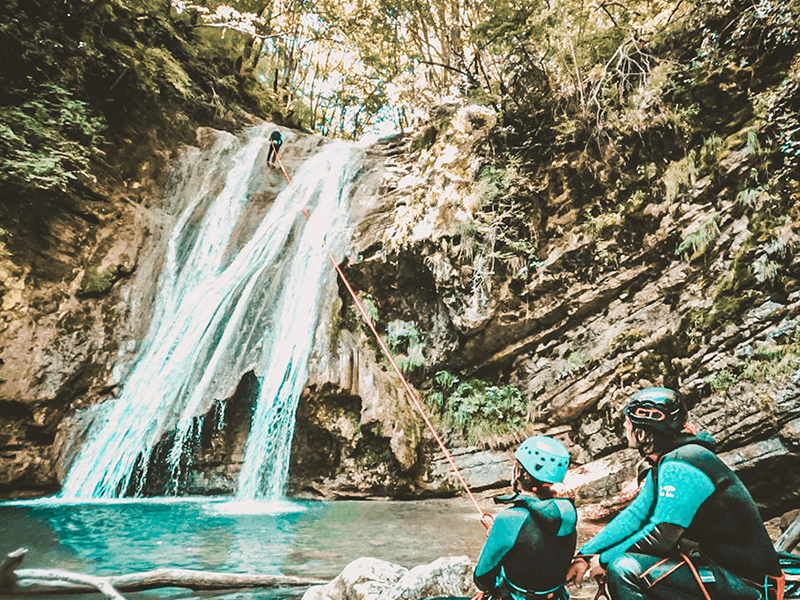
[474,436,578,600]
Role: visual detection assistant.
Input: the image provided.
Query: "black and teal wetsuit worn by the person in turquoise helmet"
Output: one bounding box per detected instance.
[474,496,578,600]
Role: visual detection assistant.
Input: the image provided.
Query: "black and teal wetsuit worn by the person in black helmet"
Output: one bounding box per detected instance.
[579,435,780,600]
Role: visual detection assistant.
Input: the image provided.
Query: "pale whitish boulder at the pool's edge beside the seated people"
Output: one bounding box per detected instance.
[302,556,477,600]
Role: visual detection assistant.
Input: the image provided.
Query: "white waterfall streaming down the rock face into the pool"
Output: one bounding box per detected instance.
[61,126,360,499]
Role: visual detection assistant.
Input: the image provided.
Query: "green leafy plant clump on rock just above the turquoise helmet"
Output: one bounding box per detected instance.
[426,371,529,444]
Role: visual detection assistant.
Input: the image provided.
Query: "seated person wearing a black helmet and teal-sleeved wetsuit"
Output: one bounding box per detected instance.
[567,387,783,600]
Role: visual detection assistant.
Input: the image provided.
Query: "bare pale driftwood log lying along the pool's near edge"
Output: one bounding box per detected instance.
[0,548,327,600]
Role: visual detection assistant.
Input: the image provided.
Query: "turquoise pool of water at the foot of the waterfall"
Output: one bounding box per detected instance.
[0,498,485,600]
